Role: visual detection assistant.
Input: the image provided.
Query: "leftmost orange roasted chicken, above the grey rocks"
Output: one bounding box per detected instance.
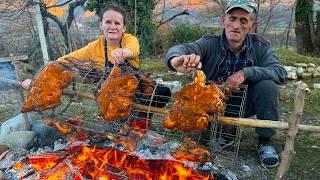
[21,62,73,112]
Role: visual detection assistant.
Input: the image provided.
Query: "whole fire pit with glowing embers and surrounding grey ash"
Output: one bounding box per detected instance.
[0,131,237,179]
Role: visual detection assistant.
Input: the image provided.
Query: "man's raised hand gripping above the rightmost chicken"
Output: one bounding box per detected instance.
[170,54,202,73]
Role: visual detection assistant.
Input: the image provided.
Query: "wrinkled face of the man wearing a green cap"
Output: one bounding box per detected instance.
[222,9,256,45]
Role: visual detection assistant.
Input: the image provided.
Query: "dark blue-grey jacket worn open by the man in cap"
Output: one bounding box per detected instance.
[166,33,287,84]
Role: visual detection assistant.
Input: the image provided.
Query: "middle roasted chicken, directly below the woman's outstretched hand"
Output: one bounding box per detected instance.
[96,65,138,121]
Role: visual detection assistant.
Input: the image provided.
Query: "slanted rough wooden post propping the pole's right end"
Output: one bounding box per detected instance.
[275,81,309,180]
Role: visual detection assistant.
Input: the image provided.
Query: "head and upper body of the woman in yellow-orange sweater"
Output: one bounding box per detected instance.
[57,5,140,69]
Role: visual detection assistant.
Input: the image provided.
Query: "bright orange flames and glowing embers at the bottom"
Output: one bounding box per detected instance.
[29,146,214,180]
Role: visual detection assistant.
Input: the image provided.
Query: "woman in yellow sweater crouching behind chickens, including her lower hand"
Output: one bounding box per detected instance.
[22,5,171,129]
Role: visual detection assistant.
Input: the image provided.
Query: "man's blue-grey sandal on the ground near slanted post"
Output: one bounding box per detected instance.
[257,145,279,168]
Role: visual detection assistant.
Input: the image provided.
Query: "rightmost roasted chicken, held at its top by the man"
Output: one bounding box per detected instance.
[163,70,224,132]
